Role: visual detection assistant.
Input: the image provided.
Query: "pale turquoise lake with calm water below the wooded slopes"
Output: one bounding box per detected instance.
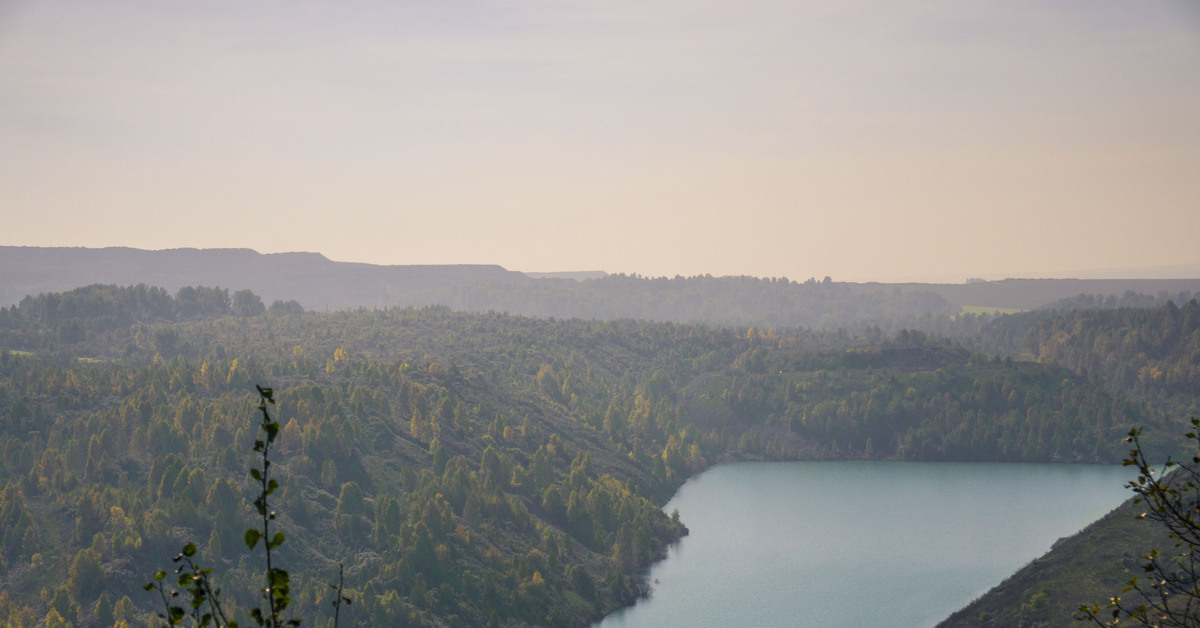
[594,461,1134,628]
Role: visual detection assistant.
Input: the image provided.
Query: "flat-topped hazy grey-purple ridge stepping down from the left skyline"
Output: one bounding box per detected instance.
[0,246,523,310]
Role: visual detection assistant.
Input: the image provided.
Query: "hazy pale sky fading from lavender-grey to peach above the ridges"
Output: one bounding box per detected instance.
[0,0,1200,281]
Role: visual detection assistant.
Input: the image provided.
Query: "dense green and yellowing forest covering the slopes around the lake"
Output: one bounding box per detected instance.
[0,285,1200,627]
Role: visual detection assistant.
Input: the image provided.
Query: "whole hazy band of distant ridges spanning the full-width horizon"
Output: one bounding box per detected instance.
[0,246,1200,321]
